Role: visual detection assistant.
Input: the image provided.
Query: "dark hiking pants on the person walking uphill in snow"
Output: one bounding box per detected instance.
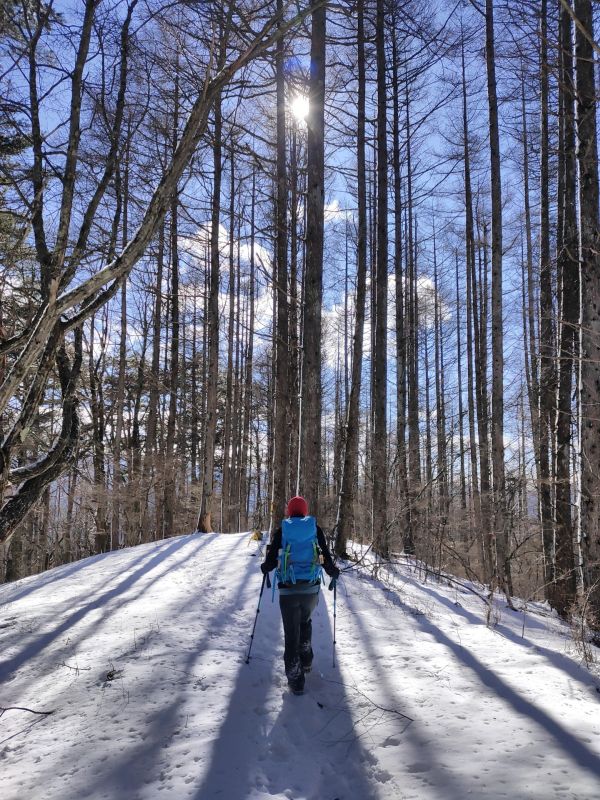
[279,592,319,687]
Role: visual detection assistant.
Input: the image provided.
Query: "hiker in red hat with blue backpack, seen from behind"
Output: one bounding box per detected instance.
[260,496,340,694]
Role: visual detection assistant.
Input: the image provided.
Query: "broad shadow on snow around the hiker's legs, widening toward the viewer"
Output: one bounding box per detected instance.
[194,580,377,800]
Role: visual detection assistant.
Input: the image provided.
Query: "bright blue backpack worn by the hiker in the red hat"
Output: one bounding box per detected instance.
[276,517,322,583]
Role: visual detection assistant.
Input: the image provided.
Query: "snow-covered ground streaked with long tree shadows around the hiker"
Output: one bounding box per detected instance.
[0,534,600,800]
